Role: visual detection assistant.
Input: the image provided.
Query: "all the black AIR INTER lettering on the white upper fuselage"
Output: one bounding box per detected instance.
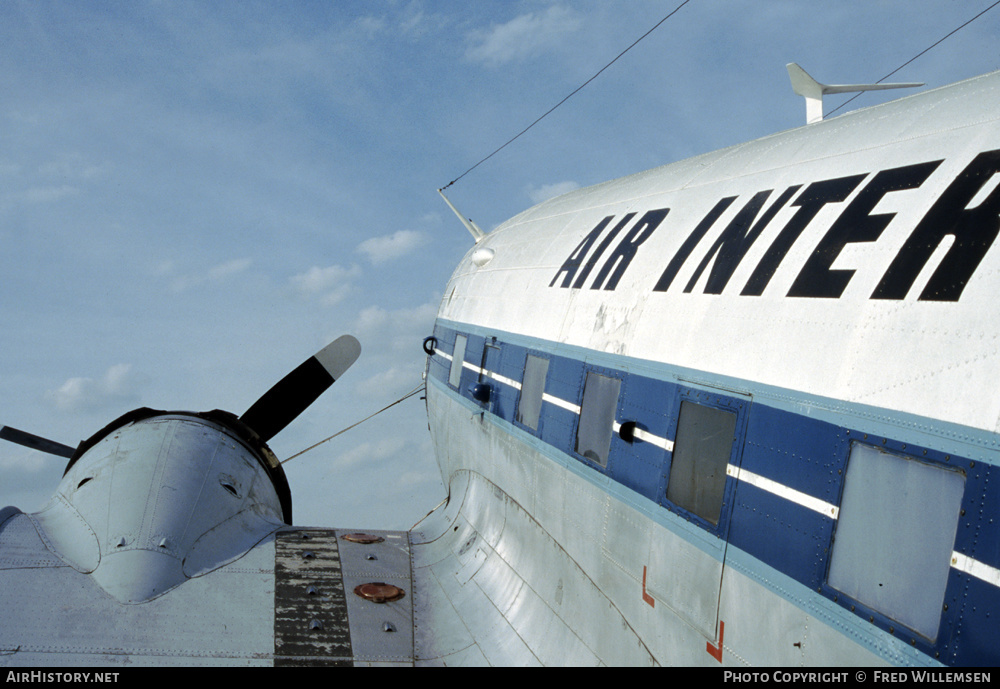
[549,150,1000,301]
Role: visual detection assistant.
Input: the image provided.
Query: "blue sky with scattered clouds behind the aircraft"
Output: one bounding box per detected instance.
[0,0,1000,528]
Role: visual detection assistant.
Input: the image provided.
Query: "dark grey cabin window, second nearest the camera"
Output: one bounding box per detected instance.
[667,400,736,524]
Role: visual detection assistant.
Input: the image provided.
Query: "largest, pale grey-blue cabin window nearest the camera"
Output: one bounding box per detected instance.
[827,444,965,640]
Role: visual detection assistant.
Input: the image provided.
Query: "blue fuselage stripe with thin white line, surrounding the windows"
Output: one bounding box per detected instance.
[428,320,1000,664]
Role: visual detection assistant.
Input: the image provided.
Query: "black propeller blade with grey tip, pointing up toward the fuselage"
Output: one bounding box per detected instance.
[240,335,361,443]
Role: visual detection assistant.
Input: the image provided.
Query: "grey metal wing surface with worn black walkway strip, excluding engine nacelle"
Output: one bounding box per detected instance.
[0,508,413,667]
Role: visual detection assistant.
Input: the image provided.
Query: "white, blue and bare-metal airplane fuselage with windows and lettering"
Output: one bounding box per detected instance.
[415,74,1000,665]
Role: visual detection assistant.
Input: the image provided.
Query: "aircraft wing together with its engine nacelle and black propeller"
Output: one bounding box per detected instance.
[0,335,428,666]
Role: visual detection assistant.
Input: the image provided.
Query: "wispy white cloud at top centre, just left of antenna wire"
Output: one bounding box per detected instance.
[465,5,582,67]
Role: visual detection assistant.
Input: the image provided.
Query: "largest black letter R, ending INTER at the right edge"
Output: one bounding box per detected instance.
[871,151,1000,301]
